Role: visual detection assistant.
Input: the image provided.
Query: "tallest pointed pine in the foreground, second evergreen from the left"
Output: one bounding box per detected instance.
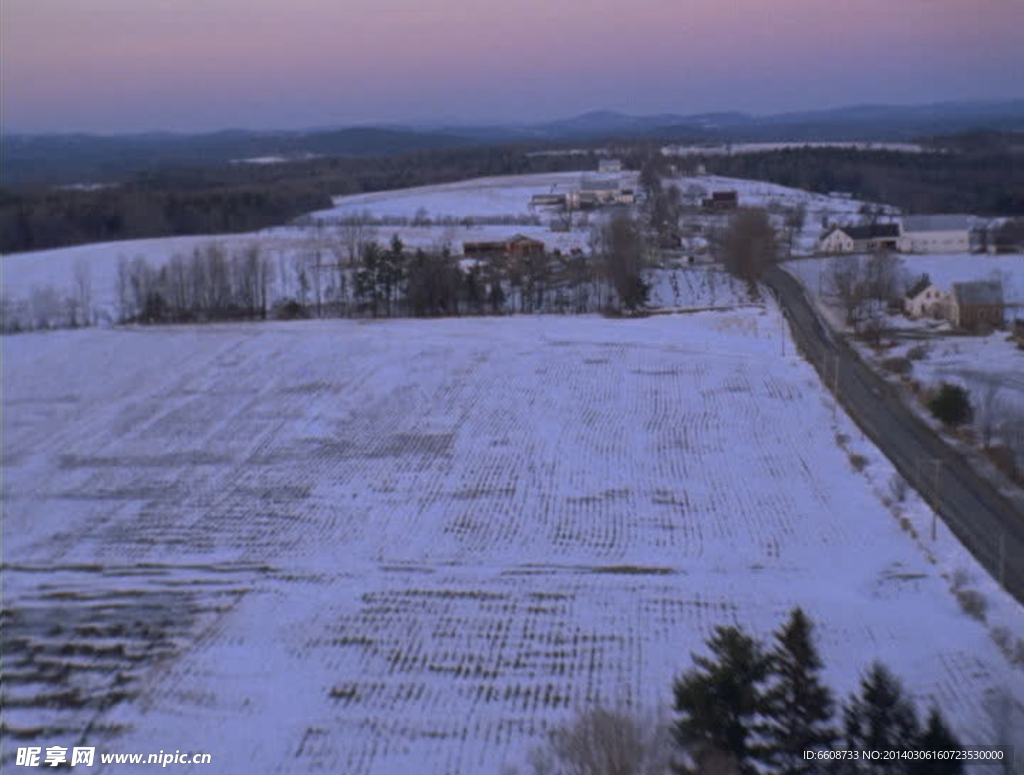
[759,608,838,775]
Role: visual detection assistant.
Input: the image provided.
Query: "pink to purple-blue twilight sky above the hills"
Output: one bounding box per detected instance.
[0,0,1024,132]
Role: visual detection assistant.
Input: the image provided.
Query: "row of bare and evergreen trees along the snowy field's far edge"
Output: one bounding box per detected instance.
[2,209,649,332]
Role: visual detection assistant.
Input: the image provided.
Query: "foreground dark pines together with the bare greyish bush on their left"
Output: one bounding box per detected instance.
[531,608,987,775]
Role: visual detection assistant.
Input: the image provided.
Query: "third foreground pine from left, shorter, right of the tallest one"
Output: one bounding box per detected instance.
[843,662,919,775]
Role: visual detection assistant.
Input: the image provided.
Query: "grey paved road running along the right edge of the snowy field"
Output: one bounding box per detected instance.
[765,267,1024,603]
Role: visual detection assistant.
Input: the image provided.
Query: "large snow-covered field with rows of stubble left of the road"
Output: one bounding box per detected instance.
[2,308,1024,775]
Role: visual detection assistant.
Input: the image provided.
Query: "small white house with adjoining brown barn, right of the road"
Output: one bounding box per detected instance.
[903,274,1007,331]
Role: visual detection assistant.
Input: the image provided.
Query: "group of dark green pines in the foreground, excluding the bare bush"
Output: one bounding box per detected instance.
[674,608,963,775]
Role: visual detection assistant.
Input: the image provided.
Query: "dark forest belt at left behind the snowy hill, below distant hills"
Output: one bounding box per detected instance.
[0,146,597,253]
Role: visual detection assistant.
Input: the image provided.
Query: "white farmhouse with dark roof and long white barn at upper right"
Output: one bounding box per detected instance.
[818,215,1015,253]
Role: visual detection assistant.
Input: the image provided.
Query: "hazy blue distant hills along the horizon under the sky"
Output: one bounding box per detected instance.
[8,99,1024,184]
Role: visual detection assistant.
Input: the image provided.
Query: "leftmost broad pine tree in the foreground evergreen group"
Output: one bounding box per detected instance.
[674,627,768,773]
